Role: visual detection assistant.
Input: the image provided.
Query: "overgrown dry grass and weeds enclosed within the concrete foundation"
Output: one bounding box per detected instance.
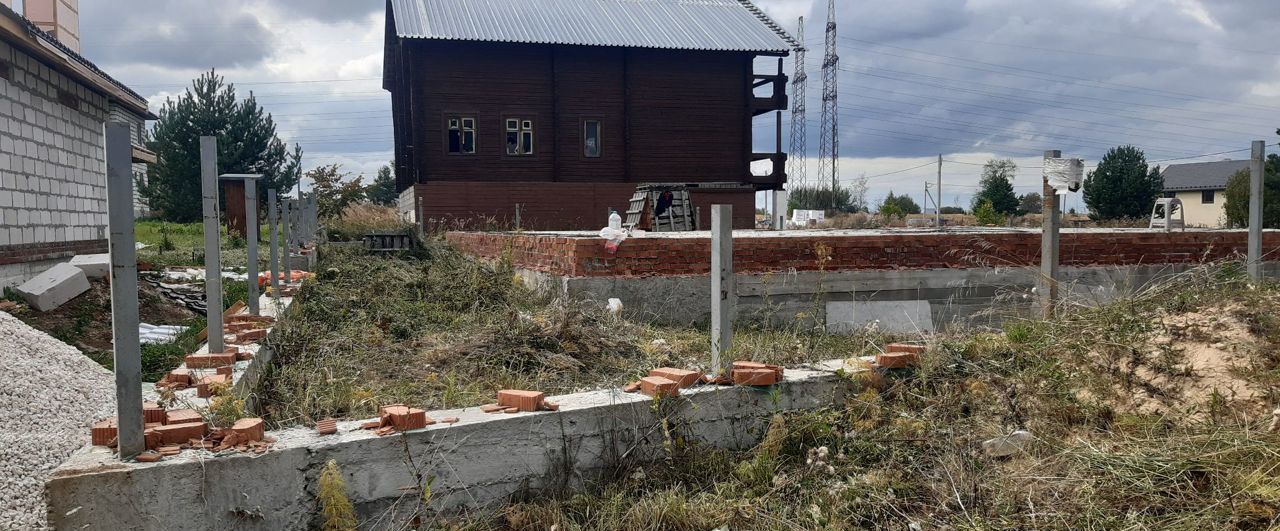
[261,243,882,425]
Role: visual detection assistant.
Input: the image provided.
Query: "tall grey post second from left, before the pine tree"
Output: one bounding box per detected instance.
[200,137,225,352]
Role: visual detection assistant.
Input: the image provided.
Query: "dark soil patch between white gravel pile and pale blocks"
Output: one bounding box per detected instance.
[6,280,196,353]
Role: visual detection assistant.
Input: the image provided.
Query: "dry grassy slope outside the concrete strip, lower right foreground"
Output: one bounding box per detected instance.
[440,266,1280,530]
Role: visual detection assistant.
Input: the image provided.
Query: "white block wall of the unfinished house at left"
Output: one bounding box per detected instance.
[0,36,109,261]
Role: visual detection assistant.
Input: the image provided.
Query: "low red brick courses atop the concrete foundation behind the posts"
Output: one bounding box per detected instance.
[448,230,1280,276]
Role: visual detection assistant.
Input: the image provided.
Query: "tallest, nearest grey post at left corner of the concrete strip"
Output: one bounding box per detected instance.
[106,122,146,461]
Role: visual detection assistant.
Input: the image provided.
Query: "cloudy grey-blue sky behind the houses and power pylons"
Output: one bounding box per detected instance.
[45,0,1280,210]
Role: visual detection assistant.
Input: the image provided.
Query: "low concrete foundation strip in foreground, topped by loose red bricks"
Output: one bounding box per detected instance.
[46,361,852,530]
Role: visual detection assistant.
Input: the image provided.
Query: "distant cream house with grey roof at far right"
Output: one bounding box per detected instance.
[1162,160,1249,226]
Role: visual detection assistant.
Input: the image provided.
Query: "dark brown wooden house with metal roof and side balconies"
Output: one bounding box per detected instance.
[383,0,796,229]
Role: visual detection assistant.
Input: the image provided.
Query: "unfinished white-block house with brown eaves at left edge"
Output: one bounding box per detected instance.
[0,0,155,287]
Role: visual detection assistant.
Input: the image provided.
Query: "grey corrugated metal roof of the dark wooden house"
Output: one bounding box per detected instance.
[392,0,796,54]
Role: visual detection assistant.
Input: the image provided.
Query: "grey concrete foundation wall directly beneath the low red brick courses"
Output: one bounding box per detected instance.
[518,262,1280,331]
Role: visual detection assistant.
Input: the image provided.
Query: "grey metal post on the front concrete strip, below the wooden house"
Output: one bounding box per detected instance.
[710,205,737,375]
